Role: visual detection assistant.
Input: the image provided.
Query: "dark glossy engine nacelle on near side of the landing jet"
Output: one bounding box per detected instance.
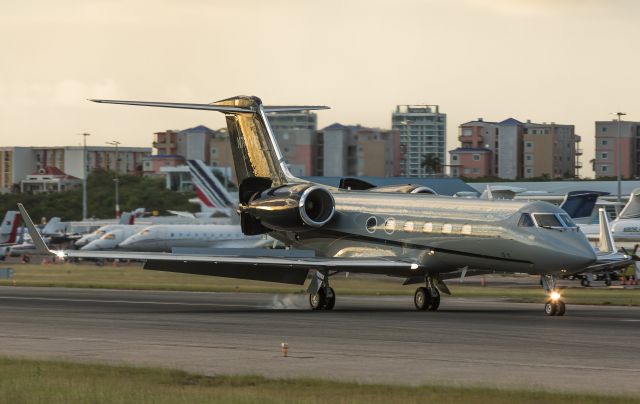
[241,184,335,232]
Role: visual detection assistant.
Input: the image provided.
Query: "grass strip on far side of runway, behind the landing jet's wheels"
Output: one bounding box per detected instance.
[0,263,640,306]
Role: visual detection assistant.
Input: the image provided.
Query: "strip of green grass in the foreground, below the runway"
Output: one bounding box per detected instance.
[0,358,639,404]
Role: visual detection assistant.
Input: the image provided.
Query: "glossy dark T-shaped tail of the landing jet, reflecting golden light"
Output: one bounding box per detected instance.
[91,96,327,186]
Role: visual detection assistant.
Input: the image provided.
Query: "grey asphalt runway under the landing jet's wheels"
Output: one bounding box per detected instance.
[0,287,640,394]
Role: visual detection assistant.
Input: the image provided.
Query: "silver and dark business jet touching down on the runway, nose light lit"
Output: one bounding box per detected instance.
[21,96,597,315]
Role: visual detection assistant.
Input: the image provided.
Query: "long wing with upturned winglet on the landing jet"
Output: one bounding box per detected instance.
[18,204,418,285]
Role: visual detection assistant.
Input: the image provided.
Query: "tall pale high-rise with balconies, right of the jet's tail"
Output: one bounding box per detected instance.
[391,105,447,177]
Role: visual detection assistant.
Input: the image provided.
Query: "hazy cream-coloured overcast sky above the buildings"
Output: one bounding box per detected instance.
[0,0,640,174]
